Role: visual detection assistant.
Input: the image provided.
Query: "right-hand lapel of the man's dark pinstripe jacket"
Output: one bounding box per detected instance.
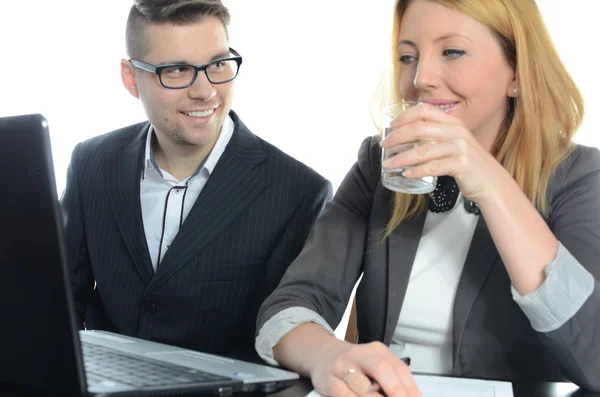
[148,112,267,291]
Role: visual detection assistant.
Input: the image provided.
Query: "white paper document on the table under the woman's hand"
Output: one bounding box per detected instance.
[306,375,514,397]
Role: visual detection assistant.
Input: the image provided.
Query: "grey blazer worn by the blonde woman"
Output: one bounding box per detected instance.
[256,137,600,390]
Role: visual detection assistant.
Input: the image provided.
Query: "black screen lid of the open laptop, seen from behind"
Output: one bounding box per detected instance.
[0,115,85,395]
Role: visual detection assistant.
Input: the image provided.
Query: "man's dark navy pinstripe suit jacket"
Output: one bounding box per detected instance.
[61,112,331,360]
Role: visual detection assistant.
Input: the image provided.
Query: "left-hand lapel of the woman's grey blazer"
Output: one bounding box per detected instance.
[383,200,427,345]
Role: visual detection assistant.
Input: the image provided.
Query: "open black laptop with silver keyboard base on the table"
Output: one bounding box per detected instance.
[0,114,298,396]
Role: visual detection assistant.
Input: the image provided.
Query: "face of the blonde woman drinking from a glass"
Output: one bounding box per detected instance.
[398,0,516,150]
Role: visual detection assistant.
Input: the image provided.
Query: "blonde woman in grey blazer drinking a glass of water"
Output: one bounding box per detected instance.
[256,0,600,397]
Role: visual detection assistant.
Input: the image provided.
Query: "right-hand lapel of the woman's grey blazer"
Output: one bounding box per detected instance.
[452,216,500,367]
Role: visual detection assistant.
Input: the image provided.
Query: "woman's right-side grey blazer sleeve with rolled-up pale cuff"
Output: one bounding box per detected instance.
[513,145,600,391]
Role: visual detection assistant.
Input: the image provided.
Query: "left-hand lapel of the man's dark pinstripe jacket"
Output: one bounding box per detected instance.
[104,123,154,282]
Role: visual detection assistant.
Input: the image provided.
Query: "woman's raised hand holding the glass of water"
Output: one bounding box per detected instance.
[381,103,512,203]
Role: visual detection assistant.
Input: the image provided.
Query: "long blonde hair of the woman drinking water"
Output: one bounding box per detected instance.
[376,0,584,238]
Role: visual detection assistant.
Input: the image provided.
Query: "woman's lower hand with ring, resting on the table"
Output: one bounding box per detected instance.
[310,338,421,397]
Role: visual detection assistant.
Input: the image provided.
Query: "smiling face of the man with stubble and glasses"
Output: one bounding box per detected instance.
[121,18,233,149]
